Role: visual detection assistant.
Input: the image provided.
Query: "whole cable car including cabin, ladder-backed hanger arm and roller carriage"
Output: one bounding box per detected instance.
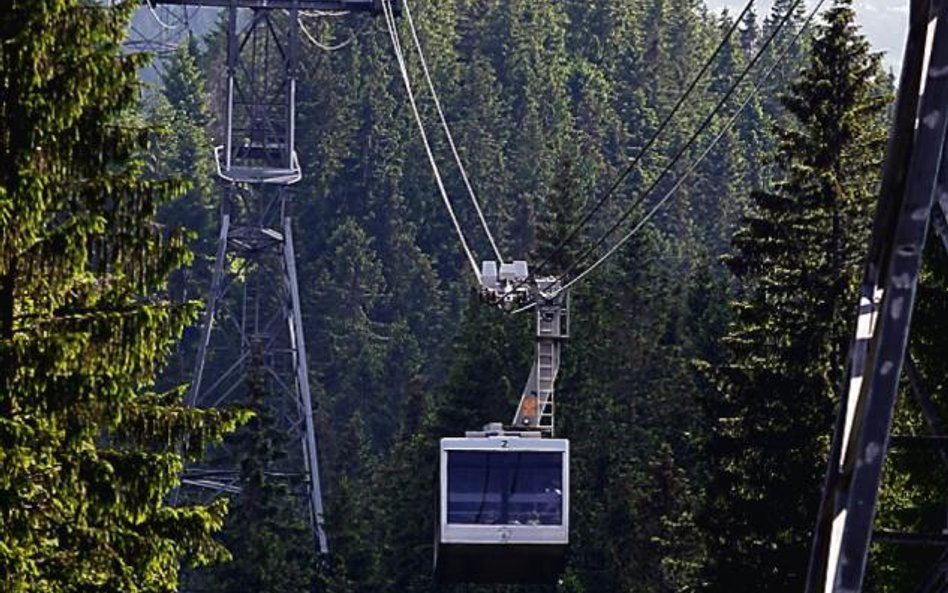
[434,261,569,584]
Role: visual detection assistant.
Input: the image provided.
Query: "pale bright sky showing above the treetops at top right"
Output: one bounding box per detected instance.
[705,0,909,72]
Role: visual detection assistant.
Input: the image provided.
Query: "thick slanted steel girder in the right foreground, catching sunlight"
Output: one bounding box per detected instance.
[806,0,948,593]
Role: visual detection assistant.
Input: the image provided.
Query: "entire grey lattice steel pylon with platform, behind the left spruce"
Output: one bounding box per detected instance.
[151,0,394,554]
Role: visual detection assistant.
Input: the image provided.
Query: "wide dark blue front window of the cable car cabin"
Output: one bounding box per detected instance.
[447,451,563,525]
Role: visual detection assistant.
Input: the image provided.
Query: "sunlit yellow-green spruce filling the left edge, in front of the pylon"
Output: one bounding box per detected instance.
[0,0,243,593]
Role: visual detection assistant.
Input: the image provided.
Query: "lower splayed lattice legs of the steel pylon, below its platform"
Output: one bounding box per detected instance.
[183,187,328,554]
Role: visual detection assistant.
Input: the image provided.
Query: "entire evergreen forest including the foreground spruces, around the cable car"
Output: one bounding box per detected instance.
[0,0,948,593]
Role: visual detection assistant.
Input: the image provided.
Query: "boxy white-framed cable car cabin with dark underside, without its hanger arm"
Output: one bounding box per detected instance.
[435,434,569,583]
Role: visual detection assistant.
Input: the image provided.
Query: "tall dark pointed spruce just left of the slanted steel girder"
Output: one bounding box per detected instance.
[705,0,888,591]
